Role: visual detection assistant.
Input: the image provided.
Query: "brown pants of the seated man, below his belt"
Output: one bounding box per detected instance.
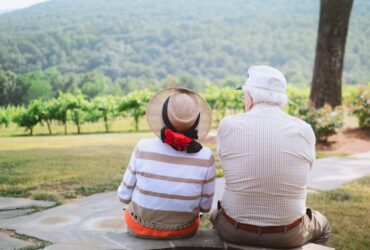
[210,208,331,248]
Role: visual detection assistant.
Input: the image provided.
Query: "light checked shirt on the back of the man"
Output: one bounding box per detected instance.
[217,104,315,226]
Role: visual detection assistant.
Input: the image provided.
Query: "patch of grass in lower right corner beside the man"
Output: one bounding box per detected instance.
[307,176,370,250]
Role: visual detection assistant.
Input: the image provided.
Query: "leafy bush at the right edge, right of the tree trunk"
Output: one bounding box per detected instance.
[352,84,370,130]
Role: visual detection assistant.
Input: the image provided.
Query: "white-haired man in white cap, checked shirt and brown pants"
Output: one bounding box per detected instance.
[210,66,331,248]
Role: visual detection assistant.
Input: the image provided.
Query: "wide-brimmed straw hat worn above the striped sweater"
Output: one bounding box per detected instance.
[146,88,212,139]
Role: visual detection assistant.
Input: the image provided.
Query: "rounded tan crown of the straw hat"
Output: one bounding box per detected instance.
[167,91,199,132]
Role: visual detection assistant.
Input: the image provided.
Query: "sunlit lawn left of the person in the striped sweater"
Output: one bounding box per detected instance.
[0,133,153,202]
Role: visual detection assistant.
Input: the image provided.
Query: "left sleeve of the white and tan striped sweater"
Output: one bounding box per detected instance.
[117,146,138,204]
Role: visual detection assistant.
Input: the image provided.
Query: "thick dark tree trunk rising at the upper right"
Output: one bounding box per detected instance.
[310,0,353,108]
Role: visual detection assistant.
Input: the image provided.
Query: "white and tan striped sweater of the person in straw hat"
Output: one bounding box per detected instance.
[117,139,215,229]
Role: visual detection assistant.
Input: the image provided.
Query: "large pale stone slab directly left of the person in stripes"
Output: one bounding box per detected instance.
[0,192,126,249]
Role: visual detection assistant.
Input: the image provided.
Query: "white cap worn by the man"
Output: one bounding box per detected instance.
[243,65,286,94]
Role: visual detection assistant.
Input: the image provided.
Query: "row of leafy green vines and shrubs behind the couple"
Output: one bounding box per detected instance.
[0,85,370,141]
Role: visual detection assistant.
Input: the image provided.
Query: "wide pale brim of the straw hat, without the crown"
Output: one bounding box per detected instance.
[146,88,212,140]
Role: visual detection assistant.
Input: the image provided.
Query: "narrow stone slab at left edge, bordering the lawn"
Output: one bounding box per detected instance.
[0,197,55,211]
